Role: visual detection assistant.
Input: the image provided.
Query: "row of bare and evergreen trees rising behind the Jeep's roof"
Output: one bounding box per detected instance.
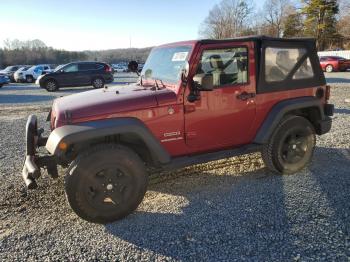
[200,0,350,50]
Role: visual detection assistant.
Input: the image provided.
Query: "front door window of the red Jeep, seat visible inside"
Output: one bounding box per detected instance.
[197,47,248,87]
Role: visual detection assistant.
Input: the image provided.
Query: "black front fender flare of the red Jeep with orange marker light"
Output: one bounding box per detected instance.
[46,117,170,164]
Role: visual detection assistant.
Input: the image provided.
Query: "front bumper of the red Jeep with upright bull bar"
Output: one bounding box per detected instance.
[22,115,58,189]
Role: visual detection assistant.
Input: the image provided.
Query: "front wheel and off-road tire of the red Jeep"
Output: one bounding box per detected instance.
[65,144,148,224]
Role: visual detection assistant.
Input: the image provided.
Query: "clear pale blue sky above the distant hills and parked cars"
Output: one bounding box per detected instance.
[0,0,260,50]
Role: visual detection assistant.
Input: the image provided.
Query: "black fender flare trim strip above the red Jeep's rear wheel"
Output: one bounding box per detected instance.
[253,97,325,144]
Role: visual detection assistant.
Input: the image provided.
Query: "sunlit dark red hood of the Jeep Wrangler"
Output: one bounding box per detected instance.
[53,84,176,127]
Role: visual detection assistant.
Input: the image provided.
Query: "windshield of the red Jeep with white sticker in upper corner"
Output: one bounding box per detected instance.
[141,46,192,84]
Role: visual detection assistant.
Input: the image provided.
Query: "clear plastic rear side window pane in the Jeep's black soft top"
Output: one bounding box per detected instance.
[265,47,314,82]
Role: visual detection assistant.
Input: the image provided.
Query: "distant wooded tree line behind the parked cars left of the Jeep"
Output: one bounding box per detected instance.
[0,39,151,67]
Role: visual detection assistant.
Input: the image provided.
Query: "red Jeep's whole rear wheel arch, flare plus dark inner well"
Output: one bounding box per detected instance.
[253,97,325,144]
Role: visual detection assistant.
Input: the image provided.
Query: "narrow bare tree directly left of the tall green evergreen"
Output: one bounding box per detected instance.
[264,0,291,37]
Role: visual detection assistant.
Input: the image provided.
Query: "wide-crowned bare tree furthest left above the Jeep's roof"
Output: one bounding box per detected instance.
[200,0,252,39]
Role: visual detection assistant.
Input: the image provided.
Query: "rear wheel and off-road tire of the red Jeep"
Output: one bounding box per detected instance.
[261,116,316,174]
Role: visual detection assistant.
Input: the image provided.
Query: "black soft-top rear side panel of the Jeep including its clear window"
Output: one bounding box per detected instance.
[257,41,326,93]
